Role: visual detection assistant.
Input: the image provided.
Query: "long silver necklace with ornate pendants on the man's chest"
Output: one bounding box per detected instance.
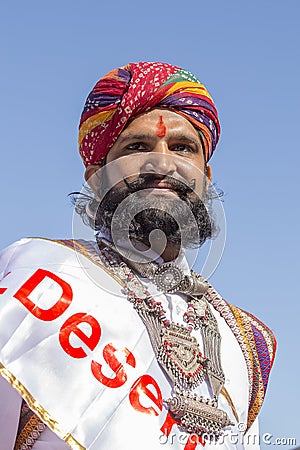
[100,241,234,440]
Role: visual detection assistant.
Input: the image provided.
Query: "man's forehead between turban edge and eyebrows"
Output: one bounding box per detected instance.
[119,108,200,140]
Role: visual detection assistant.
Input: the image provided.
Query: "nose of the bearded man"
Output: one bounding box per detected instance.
[143,141,177,175]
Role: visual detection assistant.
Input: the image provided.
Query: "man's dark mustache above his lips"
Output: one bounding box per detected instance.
[124,173,196,196]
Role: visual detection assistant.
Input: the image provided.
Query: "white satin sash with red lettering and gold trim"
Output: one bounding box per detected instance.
[0,239,253,450]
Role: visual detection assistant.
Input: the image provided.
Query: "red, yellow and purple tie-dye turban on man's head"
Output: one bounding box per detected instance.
[79,62,220,166]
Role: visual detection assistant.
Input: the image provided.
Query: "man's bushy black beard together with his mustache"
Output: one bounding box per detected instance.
[95,173,216,248]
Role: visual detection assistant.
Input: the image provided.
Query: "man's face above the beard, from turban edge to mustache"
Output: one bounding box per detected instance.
[106,109,205,196]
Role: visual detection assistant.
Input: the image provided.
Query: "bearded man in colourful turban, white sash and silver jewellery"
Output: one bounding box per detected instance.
[0,63,275,450]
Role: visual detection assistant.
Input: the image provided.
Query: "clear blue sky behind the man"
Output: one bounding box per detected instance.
[0,0,300,449]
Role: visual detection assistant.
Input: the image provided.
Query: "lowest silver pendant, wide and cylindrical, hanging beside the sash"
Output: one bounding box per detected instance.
[165,392,234,441]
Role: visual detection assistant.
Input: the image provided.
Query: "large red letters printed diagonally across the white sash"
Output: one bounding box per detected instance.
[11,269,205,450]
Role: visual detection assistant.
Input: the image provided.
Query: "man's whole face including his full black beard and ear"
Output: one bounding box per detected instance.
[86,109,213,253]
